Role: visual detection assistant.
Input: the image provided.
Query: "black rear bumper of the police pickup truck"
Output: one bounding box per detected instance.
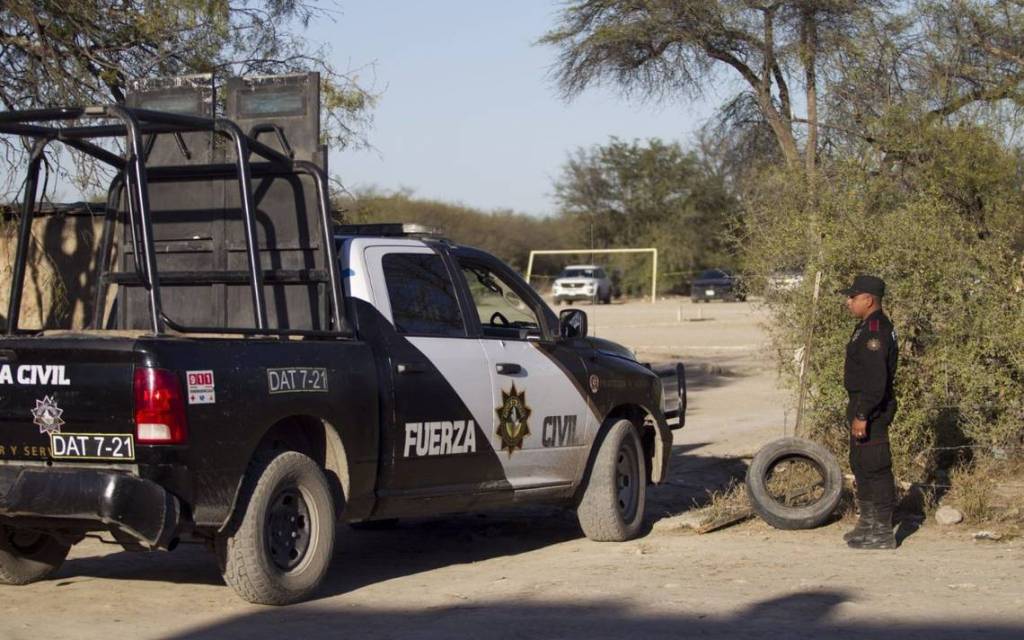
[0,467,181,549]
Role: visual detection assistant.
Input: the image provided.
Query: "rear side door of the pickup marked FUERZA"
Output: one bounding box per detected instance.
[364,243,508,498]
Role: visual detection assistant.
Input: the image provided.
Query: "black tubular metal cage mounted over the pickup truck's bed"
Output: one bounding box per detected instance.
[0,104,351,337]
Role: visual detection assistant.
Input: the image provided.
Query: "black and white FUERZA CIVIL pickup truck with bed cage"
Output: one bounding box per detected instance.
[0,82,685,604]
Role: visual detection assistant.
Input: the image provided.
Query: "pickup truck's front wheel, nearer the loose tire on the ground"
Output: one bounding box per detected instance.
[577,420,647,542]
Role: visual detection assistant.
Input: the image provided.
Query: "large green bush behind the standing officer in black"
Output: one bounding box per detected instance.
[739,123,1024,477]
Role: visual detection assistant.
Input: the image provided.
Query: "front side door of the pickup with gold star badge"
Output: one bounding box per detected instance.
[459,258,596,489]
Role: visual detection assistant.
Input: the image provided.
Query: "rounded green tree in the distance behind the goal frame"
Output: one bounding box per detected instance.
[555,138,737,292]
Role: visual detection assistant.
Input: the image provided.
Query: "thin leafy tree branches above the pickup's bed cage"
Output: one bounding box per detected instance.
[0,0,374,187]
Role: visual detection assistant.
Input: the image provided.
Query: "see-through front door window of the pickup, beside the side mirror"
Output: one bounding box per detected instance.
[461,263,541,339]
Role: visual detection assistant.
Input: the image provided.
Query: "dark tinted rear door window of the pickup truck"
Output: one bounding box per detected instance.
[381,253,466,338]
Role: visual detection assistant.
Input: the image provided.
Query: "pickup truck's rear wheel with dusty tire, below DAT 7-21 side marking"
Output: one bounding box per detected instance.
[216,452,336,605]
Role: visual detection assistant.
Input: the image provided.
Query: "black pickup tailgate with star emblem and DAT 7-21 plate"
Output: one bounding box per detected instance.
[0,335,141,462]
